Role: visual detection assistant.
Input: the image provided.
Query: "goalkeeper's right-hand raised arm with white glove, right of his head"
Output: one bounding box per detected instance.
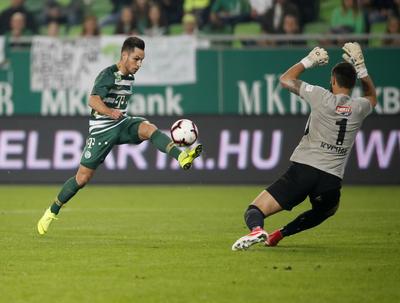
[342,42,377,107]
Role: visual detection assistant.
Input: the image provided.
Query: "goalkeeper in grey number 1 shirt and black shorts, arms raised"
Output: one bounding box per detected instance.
[232,42,377,250]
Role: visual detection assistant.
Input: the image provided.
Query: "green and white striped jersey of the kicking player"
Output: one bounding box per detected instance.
[89,64,135,135]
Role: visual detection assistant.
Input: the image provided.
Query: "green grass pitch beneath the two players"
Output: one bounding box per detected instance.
[0,185,400,303]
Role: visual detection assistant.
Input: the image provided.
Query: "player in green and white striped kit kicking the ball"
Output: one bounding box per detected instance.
[37,37,202,235]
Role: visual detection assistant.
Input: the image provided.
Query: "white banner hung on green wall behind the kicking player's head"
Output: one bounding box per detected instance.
[30,36,196,91]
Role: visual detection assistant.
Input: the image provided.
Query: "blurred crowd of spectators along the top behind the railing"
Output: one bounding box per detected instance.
[0,0,400,45]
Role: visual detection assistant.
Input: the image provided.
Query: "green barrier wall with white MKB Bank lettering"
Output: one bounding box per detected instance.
[0,48,400,116]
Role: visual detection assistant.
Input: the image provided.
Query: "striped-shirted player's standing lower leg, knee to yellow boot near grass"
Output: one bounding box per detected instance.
[37,165,94,235]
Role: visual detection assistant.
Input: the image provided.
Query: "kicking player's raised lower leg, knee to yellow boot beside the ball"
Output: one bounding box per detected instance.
[138,121,203,170]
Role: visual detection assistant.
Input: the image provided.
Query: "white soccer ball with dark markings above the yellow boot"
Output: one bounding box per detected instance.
[171,119,199,146]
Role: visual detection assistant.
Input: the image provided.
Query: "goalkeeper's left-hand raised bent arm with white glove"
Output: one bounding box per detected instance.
[279,47,329,95]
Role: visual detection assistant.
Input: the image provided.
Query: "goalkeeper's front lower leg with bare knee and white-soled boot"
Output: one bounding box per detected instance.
[232,191,282,250]
